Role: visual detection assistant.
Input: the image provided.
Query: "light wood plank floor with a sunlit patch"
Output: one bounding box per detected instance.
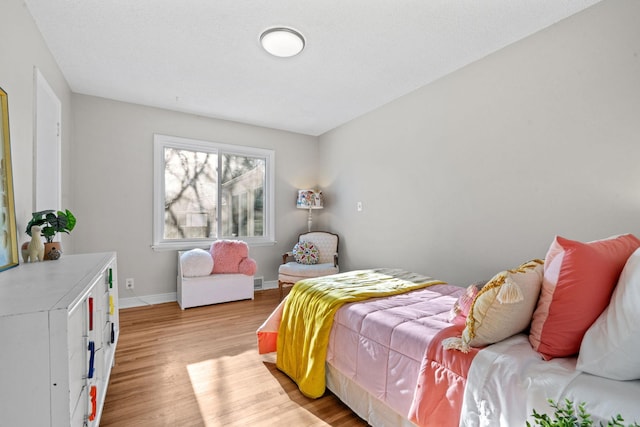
[100,290,367,427]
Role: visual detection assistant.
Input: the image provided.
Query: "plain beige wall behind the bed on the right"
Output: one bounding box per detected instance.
[320,0,640,285]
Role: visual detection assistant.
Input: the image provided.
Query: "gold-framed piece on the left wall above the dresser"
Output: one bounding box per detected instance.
[0,88,19,271]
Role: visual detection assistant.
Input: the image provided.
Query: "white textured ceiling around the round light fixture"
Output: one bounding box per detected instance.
[25,0,600,135]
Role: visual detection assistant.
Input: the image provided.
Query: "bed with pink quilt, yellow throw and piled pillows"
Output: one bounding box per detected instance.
[258,235,640,426]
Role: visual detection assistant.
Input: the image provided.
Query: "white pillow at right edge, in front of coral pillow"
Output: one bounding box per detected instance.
[576,249,640,380]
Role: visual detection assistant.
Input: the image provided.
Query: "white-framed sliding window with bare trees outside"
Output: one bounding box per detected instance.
[153,135,275,249]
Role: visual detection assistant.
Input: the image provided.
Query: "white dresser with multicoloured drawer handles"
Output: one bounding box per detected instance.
[0,252,119,427]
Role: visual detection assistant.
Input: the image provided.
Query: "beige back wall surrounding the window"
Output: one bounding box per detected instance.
[72,95,318,298]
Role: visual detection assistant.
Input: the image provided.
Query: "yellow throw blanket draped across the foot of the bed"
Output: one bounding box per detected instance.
[276,269,445,399]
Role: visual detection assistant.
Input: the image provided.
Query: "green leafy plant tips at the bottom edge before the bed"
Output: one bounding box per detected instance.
[527,399,640,427]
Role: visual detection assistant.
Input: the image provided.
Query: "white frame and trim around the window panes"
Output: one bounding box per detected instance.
[152,134,275,251]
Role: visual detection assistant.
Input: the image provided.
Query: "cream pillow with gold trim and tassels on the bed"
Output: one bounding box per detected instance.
[443,259,544,353]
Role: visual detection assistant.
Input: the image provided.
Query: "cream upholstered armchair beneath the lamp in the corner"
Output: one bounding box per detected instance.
[278,231,339,300]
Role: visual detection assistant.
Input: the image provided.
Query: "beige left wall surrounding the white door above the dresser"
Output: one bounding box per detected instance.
[0,0,74,251]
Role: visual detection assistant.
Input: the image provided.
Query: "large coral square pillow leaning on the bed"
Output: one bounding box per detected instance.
[529,234,640,360]
